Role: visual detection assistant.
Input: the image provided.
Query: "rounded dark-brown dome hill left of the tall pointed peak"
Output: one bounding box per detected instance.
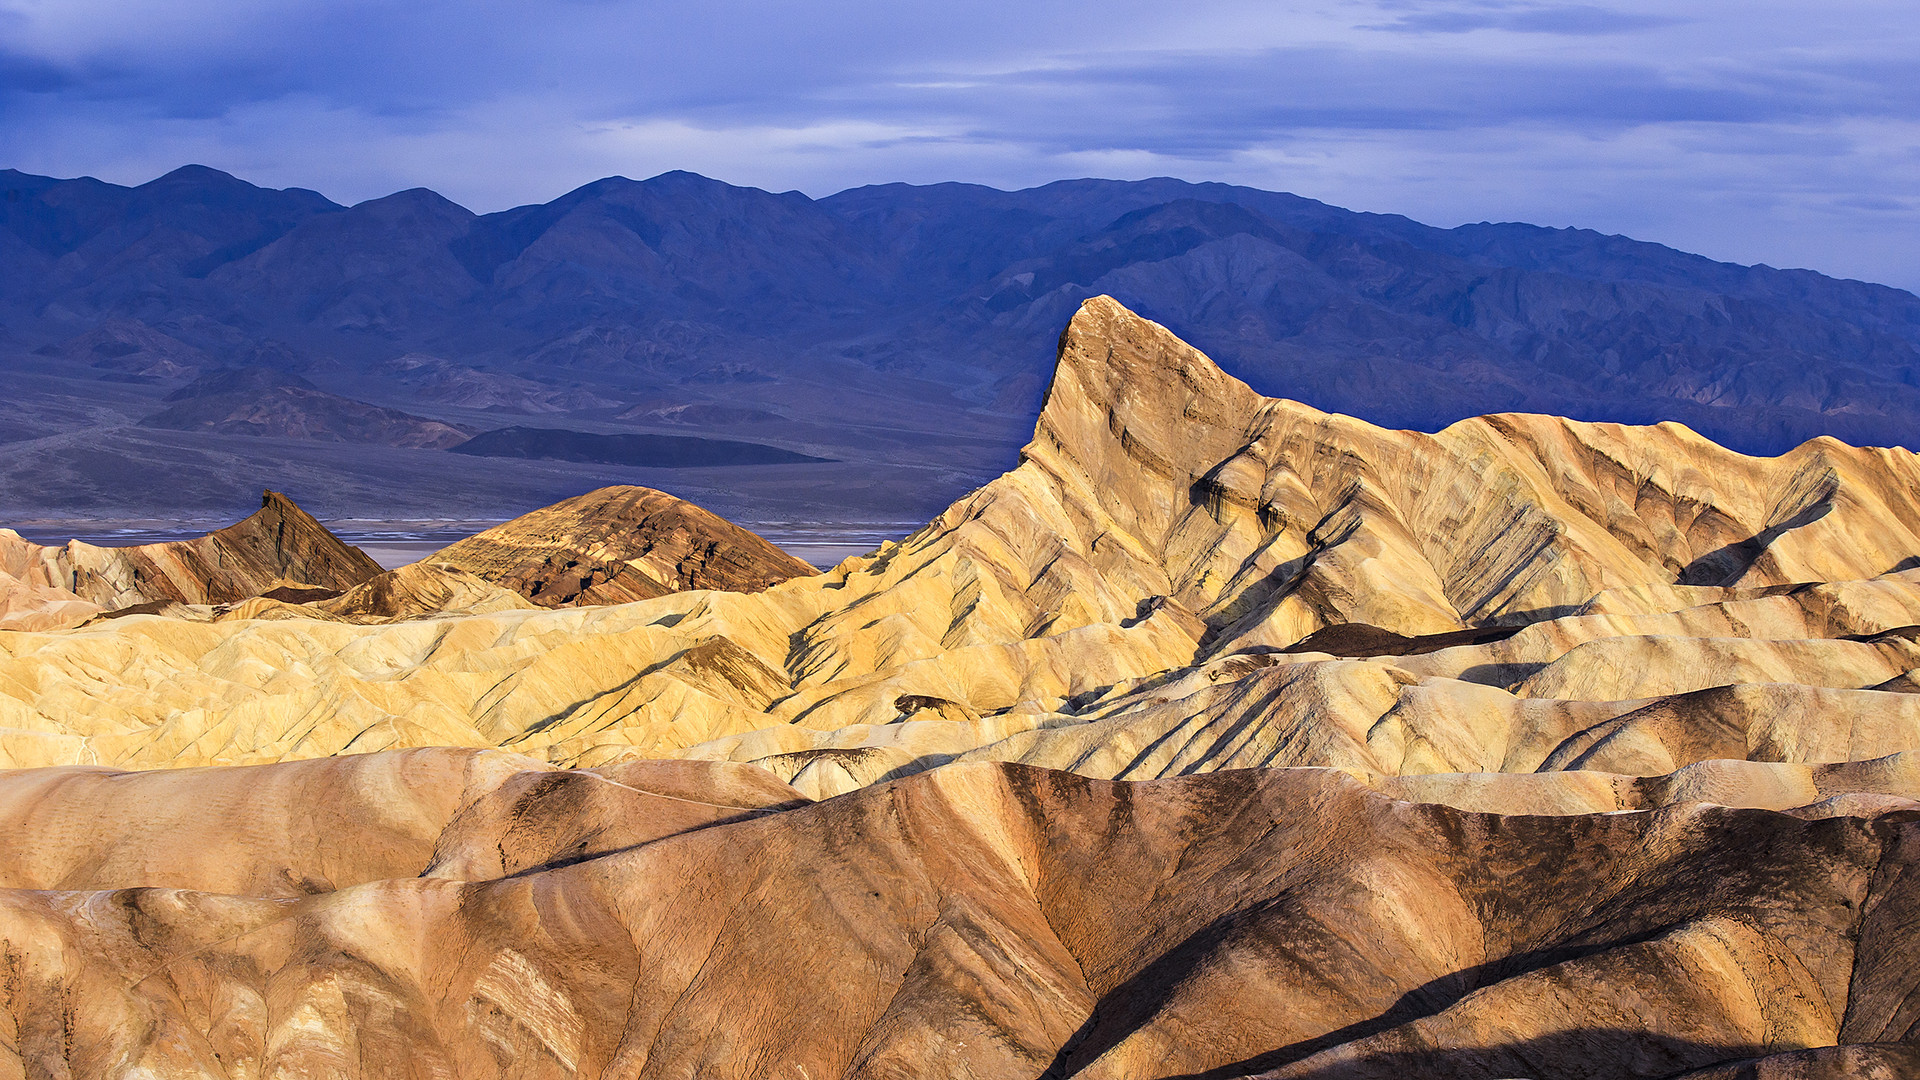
[432,486,814,607]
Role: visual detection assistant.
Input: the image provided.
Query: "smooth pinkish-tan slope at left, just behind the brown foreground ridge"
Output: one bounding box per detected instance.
[0,748,806,897]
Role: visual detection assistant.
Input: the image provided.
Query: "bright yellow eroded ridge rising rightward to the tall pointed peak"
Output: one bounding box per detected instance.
[0,298,1920,774]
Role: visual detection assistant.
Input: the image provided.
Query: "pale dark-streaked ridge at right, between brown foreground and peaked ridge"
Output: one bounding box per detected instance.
[668,573,1920,798]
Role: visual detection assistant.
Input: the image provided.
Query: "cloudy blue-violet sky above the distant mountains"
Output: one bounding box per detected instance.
[0,0,1920,290]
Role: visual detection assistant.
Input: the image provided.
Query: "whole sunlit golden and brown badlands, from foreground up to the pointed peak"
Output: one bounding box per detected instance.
[0,300,1920,1080]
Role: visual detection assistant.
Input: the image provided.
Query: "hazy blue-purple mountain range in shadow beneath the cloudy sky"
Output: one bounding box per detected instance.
[0,165,1920,515]
